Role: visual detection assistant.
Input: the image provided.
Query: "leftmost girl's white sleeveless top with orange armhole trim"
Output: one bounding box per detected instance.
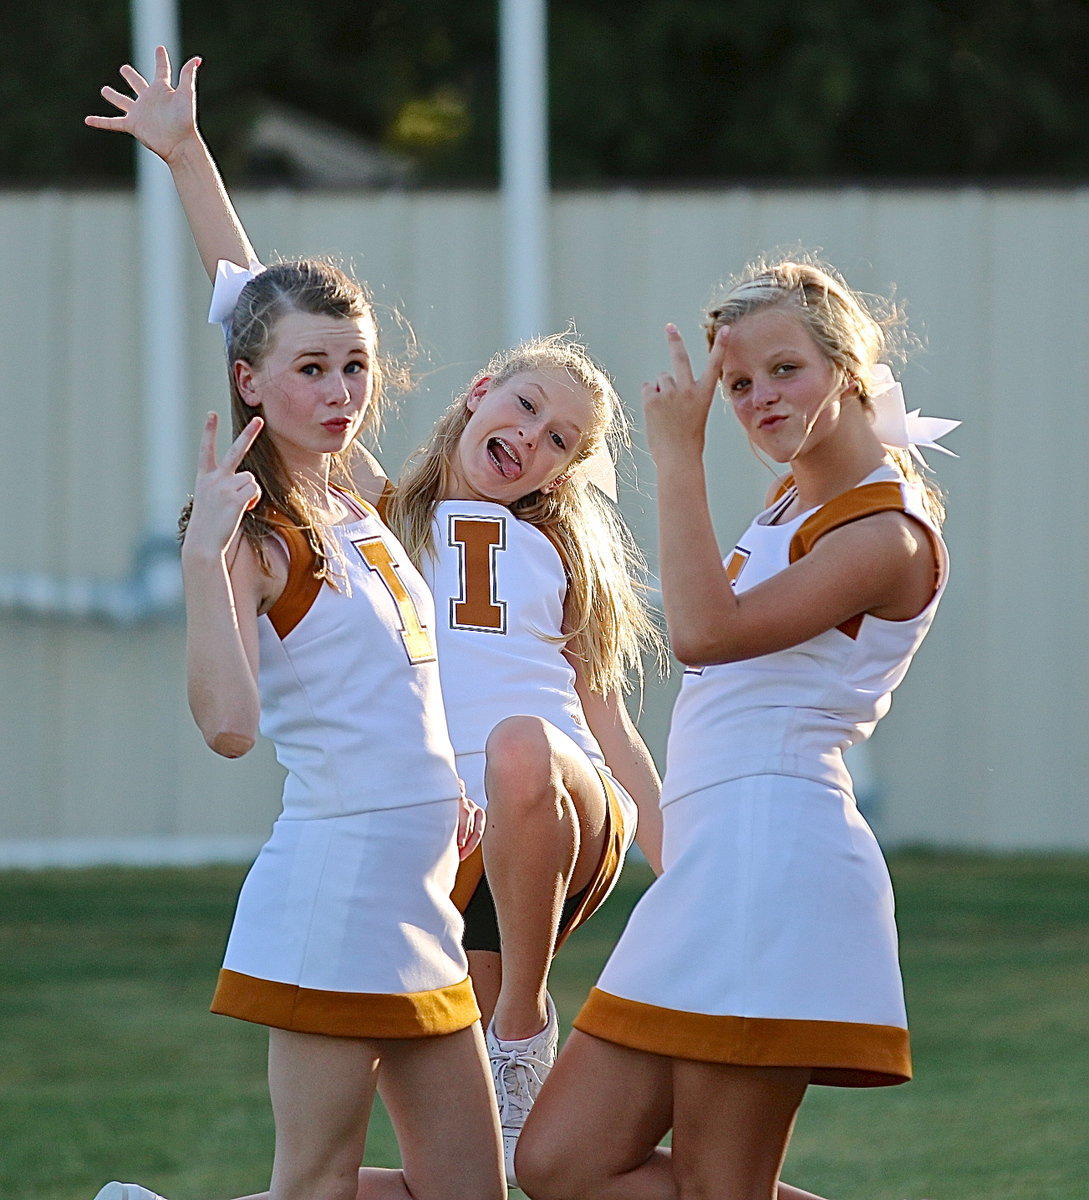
[258,494,458,818]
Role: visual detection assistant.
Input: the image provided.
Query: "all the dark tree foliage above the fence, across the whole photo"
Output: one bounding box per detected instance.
[0,0,1089,186]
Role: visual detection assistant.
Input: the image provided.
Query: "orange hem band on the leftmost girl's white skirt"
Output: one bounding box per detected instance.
[211,970,480,1038]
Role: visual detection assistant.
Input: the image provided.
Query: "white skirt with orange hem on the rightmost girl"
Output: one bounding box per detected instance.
[574,775,911,1086]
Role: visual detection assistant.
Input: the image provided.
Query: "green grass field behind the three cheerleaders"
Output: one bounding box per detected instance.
[0,854,1089,1200]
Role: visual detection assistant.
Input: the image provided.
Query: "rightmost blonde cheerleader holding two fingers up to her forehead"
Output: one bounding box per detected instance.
[517,262,956,1200]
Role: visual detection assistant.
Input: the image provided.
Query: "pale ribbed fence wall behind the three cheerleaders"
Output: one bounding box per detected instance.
[0,190,1089,865]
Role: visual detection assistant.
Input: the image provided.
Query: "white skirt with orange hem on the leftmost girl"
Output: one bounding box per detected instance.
[212,800,479,1038]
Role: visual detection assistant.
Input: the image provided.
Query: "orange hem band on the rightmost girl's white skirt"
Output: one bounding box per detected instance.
[574,988,911,1087]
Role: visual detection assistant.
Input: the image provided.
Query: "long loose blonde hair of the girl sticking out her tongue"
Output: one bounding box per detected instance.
[387,334,663,695]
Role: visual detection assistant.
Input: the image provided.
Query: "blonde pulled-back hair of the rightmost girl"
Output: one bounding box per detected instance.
[704,259,945,527]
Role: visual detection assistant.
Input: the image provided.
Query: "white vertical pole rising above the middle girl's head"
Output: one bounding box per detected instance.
[499,0,549,343]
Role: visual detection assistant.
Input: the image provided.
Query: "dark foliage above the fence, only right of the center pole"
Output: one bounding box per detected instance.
[552,0,1089,184]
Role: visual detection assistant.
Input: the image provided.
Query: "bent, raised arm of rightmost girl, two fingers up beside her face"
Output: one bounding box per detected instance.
[643,326,937,667]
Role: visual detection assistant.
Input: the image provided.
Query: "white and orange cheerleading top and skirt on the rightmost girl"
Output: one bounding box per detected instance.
[574,466,946,1086]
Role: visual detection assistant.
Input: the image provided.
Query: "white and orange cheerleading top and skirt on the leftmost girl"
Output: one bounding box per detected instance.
[212,497,479,1038]
